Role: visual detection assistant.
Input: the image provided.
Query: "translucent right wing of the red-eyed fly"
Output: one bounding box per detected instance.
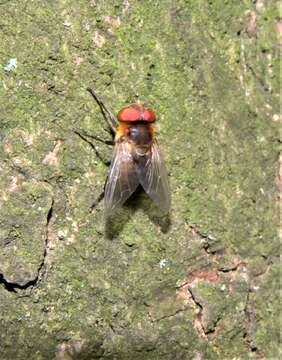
[137,140,170,213]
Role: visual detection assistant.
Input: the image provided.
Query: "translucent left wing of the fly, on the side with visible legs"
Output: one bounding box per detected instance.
[105,142,139,215]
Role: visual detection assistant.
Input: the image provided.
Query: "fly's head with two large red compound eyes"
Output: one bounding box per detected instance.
[117,102,156,123]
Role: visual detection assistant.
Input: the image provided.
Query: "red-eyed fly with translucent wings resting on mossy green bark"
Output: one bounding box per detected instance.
[81,89,170,216]
